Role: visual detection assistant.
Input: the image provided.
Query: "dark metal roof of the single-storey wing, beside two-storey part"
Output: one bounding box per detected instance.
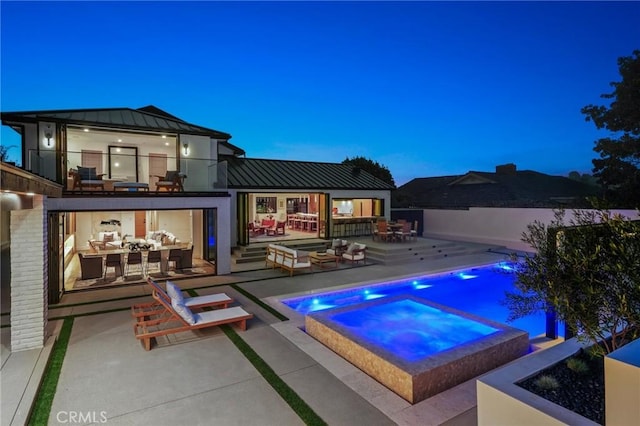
[225,157,393,190]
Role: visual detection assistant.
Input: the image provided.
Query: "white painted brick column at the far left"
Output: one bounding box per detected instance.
[10,201,48,352]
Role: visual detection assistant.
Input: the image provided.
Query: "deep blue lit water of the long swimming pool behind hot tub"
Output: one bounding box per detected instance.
[282,262,545,337]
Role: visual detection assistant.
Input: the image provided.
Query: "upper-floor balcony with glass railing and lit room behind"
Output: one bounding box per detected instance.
[24,149,227,195]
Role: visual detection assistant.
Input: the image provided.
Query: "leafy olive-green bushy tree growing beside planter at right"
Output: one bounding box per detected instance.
[505,210,640,353]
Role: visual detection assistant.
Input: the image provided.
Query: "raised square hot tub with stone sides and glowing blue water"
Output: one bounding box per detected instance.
[305,296,529,404]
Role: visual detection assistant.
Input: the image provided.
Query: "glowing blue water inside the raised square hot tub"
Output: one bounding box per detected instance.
[327,299,498,362]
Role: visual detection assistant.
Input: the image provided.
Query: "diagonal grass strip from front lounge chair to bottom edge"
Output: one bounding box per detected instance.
[220,325,327,426]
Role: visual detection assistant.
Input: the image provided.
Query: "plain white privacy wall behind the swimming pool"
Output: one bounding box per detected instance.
[423,207,639,251]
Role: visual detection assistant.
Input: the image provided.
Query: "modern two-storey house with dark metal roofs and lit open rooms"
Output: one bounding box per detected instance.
[1,106,392,352]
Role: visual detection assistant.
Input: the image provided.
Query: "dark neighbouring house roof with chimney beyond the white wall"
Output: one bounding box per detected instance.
[392,170,599,208]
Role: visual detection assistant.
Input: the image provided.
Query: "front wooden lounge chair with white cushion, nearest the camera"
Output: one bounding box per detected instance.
[133,280,253,351]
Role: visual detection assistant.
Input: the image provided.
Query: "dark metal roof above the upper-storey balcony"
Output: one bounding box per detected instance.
[2,105,231,140]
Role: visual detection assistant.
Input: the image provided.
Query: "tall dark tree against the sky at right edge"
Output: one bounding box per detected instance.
[581,50,640,207]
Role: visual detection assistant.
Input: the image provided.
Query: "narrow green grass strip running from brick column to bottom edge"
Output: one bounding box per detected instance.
[28,317,73,426]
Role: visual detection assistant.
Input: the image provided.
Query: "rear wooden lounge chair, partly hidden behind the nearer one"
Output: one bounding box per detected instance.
[131,278,233,321]
